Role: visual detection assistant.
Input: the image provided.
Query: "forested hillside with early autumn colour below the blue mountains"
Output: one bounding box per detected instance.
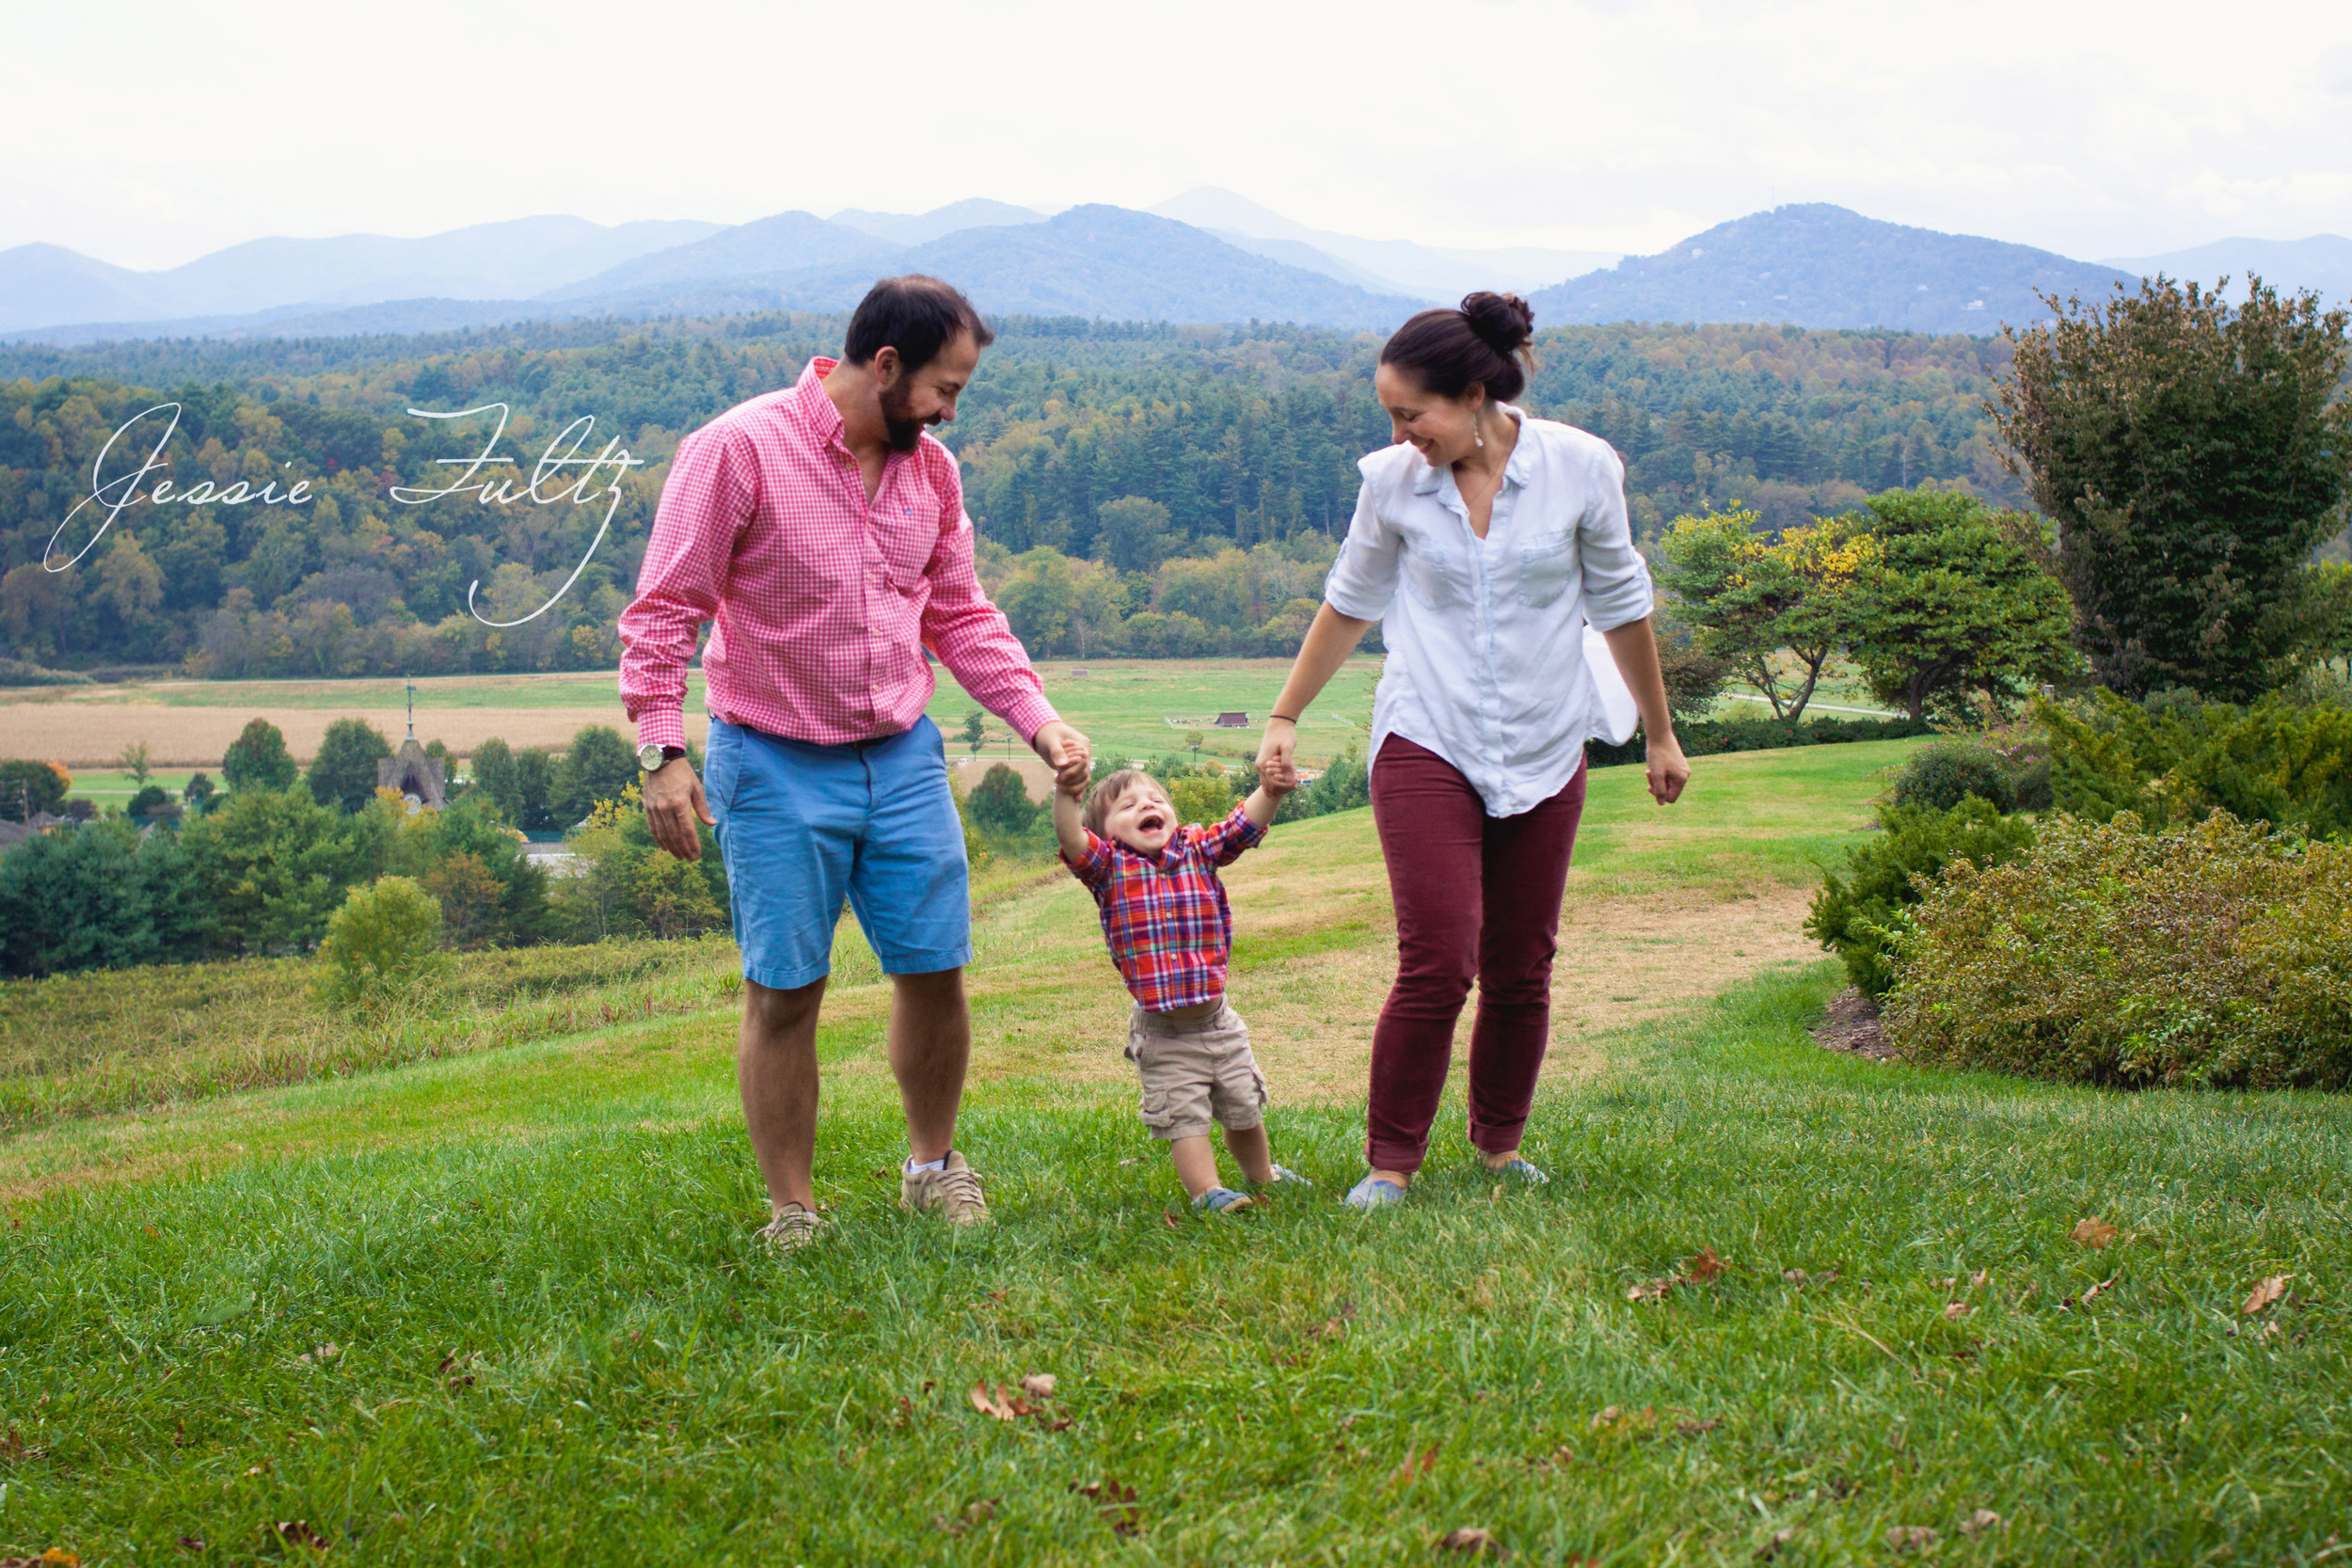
[0,315,2023,674]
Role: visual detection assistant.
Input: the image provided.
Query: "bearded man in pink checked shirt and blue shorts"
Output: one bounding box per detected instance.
[621,277,1089,1251]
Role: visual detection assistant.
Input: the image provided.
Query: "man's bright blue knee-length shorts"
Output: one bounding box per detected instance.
[704,720,972,990]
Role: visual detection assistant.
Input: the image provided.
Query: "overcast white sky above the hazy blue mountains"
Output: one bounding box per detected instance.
[0,0,2352,268]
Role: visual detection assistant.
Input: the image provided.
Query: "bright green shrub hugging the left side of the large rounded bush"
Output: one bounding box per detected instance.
[1804,797,2035,997]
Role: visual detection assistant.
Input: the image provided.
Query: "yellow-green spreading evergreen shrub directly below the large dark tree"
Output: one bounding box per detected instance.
[2035,691,2352,837]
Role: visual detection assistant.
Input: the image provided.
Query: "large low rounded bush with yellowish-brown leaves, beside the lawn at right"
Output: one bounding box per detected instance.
[1884,811,2352,1088]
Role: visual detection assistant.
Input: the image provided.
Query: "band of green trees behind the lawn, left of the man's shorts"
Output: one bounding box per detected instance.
[0,720,727,975]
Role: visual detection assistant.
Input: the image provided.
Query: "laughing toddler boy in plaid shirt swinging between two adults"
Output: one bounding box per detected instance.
[1054,762,1306,1213]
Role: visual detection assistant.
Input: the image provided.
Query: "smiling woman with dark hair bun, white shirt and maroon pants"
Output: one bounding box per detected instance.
[1259,293,1692,1209]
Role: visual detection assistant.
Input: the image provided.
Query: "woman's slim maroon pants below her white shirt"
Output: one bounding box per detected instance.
[1364,736,1585,1173]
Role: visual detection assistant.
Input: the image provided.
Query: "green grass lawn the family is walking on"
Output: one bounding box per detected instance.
[0,745,2352,1563]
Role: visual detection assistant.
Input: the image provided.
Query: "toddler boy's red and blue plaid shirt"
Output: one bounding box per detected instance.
[1063,806,1265,1013]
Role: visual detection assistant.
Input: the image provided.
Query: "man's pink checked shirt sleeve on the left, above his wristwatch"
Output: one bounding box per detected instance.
[621,430,760,745]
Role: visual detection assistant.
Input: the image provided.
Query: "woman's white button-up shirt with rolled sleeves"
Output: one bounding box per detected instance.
[1325,404,1651,816]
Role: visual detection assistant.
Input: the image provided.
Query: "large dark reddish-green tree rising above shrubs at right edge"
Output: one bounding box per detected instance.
[1988,277,2352,701]
